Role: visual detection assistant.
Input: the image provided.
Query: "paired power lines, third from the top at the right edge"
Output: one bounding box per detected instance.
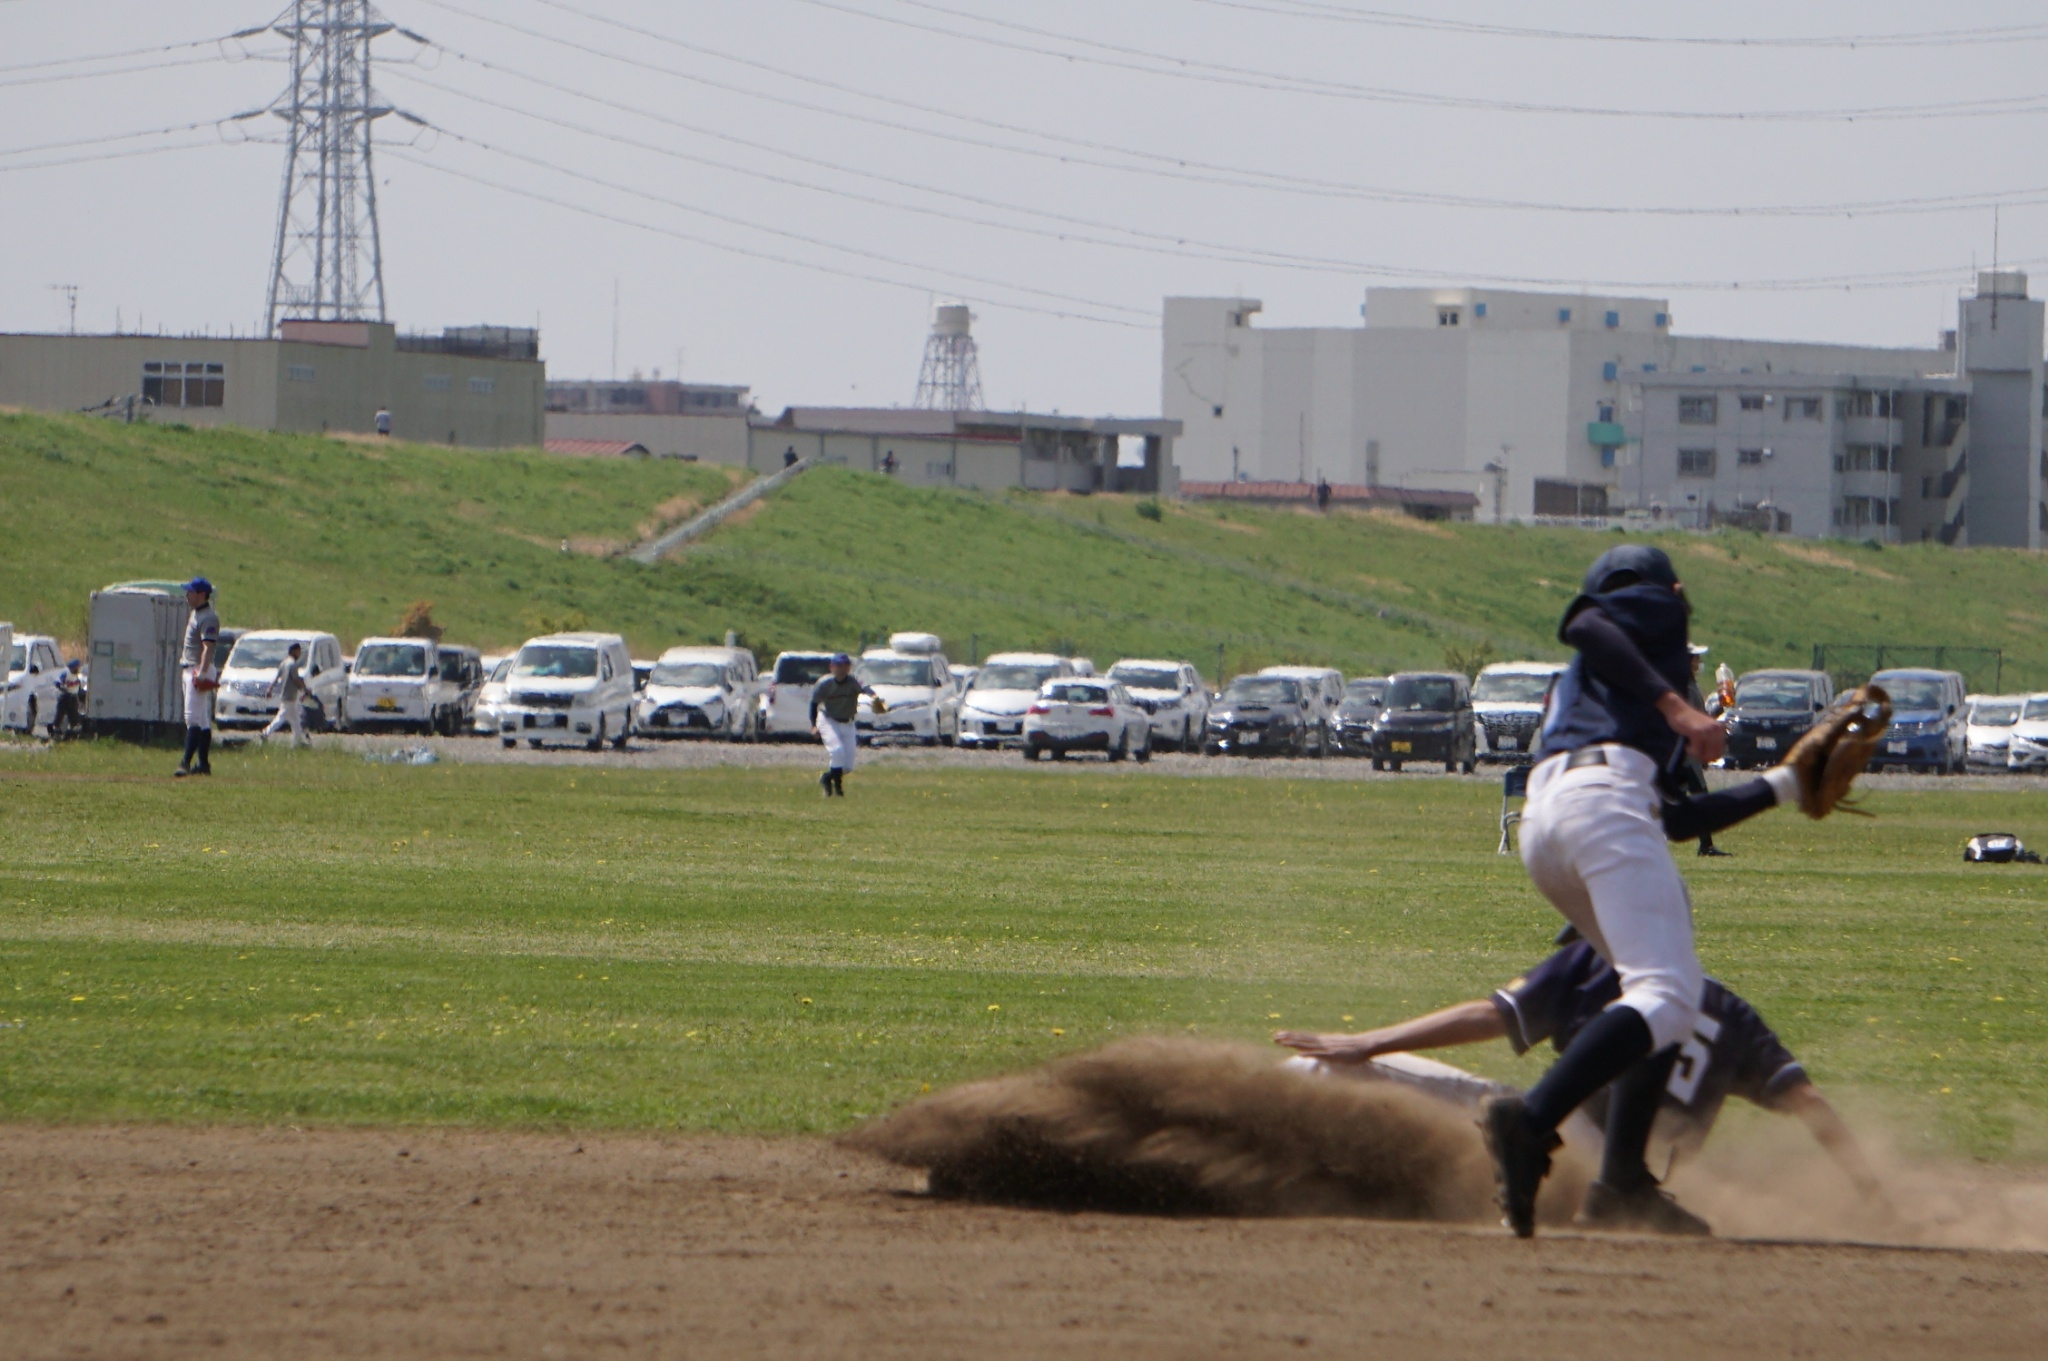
[499,0,2048,217]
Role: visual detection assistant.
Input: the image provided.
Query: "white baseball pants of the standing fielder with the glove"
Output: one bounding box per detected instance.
[1522,745,1706,1050]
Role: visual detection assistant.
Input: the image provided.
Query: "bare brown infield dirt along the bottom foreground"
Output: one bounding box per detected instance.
[0,1126,2048,1361]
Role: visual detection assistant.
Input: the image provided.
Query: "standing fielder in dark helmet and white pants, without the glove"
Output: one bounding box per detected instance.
[1481,544,1798,1238]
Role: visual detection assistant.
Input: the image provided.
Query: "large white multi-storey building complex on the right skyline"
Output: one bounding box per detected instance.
[1161,274,2048,544]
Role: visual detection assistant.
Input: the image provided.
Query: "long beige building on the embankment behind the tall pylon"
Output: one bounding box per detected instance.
[0,321,547,448]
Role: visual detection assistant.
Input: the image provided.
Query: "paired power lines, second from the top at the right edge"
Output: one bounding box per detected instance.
[795,0,2048,123]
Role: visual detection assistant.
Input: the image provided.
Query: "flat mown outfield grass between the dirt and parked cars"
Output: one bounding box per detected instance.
[0,745,2048,1156]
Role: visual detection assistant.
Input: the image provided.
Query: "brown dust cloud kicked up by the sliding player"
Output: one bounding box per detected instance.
[846,1038,1585,1222]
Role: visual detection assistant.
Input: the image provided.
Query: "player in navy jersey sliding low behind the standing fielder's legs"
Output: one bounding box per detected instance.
[1274,927,1884,1232]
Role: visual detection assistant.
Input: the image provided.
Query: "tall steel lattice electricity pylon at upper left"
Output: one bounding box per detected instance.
[264,0,409,336]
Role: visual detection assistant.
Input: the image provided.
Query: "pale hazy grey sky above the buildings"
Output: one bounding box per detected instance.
[0,0,2048,413]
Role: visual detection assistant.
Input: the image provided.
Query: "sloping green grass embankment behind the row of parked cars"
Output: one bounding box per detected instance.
[12,413,2048,690]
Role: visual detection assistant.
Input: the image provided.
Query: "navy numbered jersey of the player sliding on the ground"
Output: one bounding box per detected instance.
[1493,941,1806,1144]
